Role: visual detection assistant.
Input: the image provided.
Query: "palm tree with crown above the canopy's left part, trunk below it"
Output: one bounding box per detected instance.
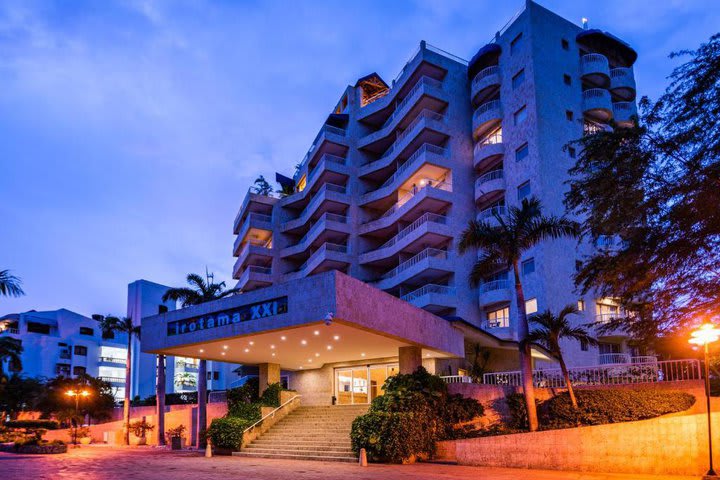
[157,272,239,448]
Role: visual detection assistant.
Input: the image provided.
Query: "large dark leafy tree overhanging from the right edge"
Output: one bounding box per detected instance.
[566,34,720,342]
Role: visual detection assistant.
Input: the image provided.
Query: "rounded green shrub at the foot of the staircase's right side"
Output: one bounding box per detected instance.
[350,412,435,463]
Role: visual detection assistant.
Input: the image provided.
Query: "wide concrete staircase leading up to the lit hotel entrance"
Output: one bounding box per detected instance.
[233,405,368,462]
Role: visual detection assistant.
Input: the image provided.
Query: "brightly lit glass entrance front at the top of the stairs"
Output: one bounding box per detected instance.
[335,363,399,405]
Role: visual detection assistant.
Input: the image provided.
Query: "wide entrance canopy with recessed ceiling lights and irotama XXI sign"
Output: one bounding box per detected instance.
[141,271,465,370]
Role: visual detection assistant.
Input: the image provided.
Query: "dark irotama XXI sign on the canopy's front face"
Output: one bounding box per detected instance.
[167,297,287,336]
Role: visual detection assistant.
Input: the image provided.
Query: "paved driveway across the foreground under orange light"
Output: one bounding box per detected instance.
[0,446,697,480]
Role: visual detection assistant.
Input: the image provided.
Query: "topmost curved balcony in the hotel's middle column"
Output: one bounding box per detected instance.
[358,77,448,148]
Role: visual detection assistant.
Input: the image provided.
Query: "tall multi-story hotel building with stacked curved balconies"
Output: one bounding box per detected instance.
[228,2,637,365]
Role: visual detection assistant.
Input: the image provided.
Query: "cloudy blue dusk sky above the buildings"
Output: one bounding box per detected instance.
[0,0,720,315]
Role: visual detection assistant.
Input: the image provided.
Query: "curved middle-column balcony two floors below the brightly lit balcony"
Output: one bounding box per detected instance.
[374,248,454,290]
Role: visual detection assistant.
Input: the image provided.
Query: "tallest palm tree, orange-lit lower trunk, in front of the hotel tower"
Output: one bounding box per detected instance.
[458,197,579,431]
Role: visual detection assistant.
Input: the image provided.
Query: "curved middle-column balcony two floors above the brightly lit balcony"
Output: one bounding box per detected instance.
[358,110,450,180]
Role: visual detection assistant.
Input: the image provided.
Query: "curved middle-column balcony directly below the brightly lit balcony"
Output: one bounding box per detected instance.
[359,213,456,264]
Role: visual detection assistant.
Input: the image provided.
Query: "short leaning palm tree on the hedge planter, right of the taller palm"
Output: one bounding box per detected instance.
[528,305,598,409]
